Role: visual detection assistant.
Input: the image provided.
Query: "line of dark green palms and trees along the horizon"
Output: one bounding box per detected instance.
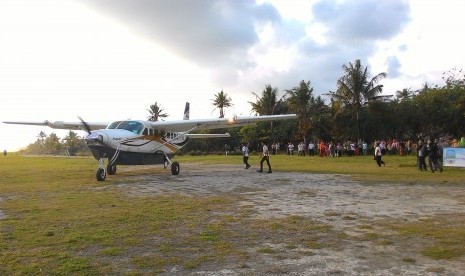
[20,59,465,154]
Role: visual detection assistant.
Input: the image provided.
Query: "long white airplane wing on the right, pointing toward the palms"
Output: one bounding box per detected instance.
[151,114,297,132]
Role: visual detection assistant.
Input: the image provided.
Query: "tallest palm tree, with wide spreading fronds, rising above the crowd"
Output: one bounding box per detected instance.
[330,59,387,139]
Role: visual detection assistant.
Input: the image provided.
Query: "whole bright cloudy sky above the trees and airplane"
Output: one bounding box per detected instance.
[0,0,465,151]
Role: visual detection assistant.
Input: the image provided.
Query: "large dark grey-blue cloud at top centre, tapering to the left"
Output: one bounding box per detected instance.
[80,0,280,66]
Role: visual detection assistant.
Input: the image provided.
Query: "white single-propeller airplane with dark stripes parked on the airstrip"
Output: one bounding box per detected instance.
[3,103,297,181]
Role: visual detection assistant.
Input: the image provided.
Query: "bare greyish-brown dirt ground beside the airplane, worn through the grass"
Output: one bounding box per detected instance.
[113,164,465,275]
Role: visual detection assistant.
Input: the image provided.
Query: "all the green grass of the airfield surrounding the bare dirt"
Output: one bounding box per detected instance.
[0,154,465,275]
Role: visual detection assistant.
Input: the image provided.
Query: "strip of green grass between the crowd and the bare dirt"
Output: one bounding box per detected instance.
[176,152,465,183]
